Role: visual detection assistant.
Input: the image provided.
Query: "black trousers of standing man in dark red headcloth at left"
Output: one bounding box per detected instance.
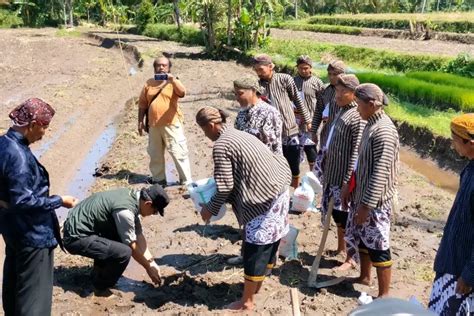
[2,236,54,316]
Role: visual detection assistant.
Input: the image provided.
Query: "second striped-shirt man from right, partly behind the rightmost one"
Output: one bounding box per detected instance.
[321,75,366,271]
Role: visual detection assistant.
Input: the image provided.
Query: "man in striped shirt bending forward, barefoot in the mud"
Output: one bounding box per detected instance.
[196,106,291,310]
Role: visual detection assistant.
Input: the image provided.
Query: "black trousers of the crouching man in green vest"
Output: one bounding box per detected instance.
[64,235,132,290]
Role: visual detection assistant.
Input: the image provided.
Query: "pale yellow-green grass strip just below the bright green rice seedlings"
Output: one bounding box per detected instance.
[385,99,460,138]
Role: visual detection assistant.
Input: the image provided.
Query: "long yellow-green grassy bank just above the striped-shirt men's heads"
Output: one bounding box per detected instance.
[259,39,456,72]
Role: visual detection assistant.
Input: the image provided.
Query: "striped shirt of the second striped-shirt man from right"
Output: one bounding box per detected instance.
[323,102,367,188]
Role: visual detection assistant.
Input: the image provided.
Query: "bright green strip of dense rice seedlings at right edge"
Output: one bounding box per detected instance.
[357,73,474,112]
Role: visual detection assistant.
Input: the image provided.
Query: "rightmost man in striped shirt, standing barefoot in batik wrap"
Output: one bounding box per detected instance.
[342,83,399,297]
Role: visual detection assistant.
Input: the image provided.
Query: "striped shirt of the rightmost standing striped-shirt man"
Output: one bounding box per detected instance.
[352,111,400,208]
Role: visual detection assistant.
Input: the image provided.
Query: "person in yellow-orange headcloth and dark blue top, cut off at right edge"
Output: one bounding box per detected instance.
[428,113,474,315]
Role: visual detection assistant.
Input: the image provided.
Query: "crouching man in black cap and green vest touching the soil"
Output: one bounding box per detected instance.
[64,184,169,296]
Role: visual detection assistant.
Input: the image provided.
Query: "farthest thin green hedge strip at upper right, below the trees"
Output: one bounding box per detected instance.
[309,16,474,33]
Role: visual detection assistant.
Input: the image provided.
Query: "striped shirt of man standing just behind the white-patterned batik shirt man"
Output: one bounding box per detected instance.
[259,73,311,137]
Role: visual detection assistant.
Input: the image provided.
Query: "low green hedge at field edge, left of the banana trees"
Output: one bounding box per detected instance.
[142,23,205,46]
